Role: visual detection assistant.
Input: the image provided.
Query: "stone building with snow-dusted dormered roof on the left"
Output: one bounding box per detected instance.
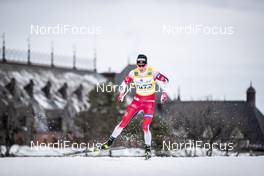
[0,62,105,145]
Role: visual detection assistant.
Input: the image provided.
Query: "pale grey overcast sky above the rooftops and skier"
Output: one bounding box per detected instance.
[0,0,264,112]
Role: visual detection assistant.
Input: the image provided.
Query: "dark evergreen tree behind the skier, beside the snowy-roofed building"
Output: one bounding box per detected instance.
[75,82,125,141]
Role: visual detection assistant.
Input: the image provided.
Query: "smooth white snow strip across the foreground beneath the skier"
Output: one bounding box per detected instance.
[0,156,264,176]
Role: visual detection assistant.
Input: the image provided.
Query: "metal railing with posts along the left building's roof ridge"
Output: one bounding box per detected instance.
[0,48,95,71]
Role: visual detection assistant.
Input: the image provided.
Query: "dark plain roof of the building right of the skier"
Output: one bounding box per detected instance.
[163,101,264,144]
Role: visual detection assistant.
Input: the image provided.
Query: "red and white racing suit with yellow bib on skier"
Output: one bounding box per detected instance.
[111,67,168,145]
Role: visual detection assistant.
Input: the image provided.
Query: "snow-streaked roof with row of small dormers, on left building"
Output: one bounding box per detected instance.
[0,62,105,132]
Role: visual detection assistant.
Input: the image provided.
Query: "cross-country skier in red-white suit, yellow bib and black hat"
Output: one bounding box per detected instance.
[101,54,168,157]
